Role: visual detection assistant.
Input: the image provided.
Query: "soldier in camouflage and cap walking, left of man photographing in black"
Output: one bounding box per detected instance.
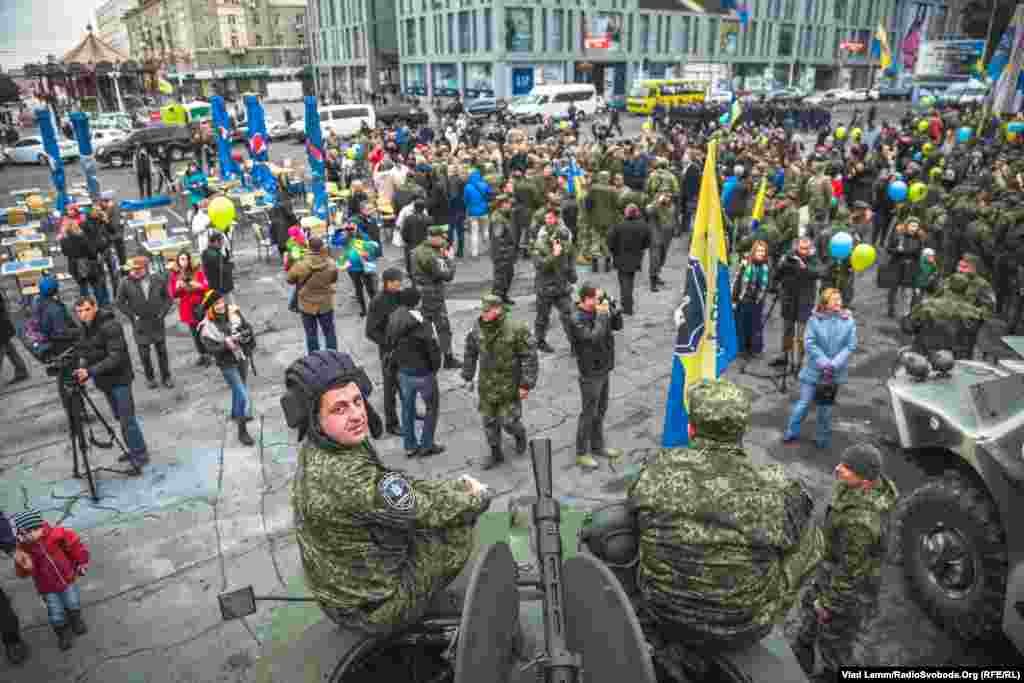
[462,294,539,469]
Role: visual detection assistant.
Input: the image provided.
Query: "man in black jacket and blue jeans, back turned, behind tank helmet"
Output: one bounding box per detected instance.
[385,287,444,458]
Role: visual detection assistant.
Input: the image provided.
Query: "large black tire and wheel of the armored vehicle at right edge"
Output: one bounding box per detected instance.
[895,473,1008,640]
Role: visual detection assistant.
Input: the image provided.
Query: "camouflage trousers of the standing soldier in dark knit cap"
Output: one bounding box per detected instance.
[794,579,866,675]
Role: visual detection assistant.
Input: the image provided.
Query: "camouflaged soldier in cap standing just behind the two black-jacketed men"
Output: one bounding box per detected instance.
[411,225,462,370]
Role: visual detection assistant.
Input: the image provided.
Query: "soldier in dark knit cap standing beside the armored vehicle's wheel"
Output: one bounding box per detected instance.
[794,443,899,681]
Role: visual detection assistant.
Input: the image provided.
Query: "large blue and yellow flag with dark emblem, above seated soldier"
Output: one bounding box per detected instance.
[662,141,738,449]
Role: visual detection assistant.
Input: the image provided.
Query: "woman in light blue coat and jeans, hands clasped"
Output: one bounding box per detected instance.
[782,288,857,449]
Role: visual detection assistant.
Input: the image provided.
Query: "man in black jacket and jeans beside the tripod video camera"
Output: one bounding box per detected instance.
[75,296,150,474]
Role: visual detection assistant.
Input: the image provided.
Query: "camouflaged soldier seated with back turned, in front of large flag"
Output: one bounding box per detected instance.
[629,380,823,656]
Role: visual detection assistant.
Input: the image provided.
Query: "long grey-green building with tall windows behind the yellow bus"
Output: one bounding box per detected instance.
[382,0,944,97]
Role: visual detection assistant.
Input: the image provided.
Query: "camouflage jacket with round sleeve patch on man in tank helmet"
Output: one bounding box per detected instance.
[292,441,484,626]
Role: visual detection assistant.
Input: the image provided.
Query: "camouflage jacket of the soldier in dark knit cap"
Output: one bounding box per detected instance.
[815,477,899,613]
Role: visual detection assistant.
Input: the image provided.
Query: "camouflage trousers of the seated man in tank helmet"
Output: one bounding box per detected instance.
[321,526,473,636]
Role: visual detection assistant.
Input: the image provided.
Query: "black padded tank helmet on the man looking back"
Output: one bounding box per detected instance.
[281,351,384,441]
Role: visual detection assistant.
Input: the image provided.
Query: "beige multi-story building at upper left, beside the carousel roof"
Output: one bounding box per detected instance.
[124,0,308,97]
